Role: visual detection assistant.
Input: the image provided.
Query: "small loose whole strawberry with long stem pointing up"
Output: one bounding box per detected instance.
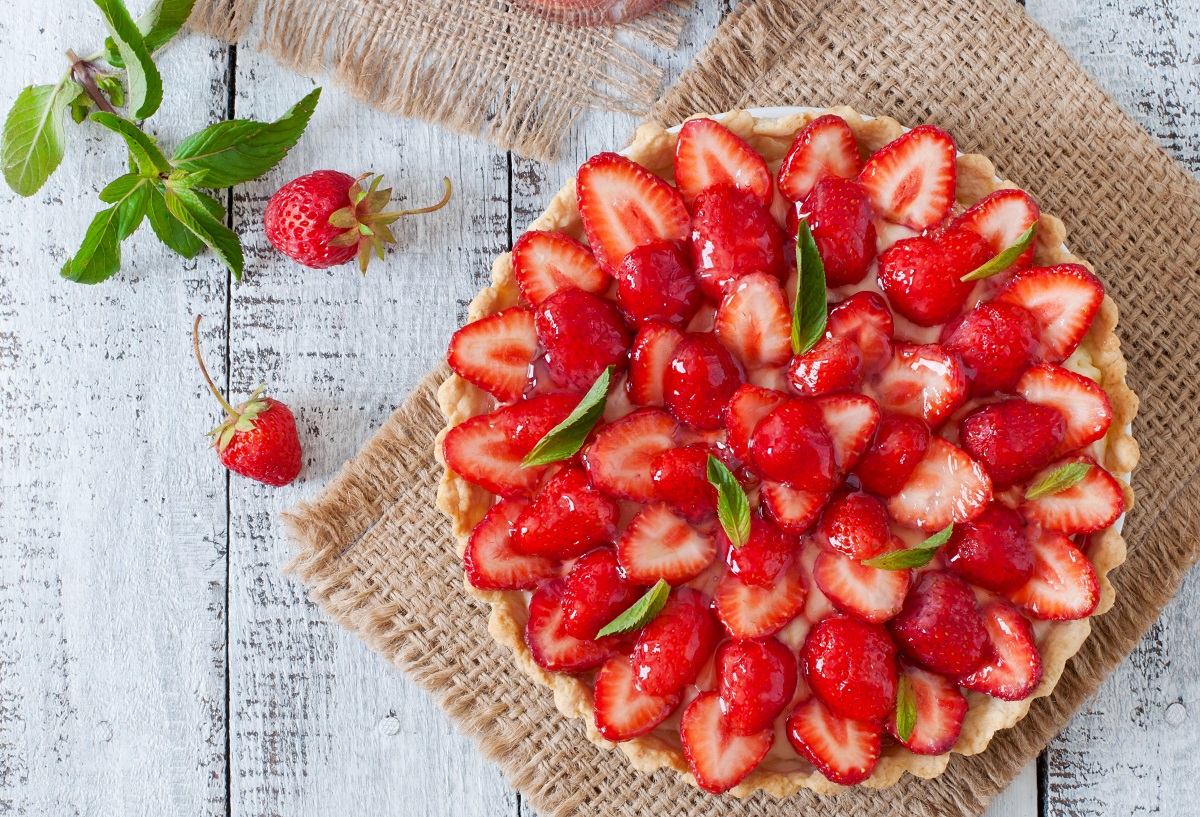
[192,316,301,487]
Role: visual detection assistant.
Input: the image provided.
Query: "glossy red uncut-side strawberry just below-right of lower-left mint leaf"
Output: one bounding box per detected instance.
[632,587,721,696]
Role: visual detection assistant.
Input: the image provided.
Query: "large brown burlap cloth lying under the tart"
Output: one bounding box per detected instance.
[289,0,1200,817]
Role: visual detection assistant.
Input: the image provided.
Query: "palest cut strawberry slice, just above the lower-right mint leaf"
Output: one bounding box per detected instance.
[888,437,991,534]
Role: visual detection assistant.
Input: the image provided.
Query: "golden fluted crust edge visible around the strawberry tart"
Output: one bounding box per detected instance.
[436,107,1139,797]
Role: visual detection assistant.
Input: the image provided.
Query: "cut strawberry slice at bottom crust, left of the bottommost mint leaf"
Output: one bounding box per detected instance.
[787,697,883,786]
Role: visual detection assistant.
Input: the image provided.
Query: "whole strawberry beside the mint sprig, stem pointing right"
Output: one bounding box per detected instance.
[263,170,450,272]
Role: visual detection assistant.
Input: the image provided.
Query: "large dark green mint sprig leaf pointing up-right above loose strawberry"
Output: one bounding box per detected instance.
[173,88,320,187]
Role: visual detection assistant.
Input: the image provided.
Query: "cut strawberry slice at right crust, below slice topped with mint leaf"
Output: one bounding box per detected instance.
[1008,525,1100,621]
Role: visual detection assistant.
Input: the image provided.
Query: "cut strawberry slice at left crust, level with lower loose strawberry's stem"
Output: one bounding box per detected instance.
[446,306,538,403]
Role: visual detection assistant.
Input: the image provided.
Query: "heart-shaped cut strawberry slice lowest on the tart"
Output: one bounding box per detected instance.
[679,692,775,794]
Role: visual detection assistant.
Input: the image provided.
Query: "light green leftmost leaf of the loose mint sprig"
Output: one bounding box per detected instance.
[0,79,83,196]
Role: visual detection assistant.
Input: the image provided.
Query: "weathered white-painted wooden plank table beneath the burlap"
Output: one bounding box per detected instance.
[0,0,1200,817]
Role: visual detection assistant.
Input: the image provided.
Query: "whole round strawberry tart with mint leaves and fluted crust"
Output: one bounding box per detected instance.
[437,108,1138,797]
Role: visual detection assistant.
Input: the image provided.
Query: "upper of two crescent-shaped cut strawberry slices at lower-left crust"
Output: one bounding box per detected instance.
[462,499,559,590]
